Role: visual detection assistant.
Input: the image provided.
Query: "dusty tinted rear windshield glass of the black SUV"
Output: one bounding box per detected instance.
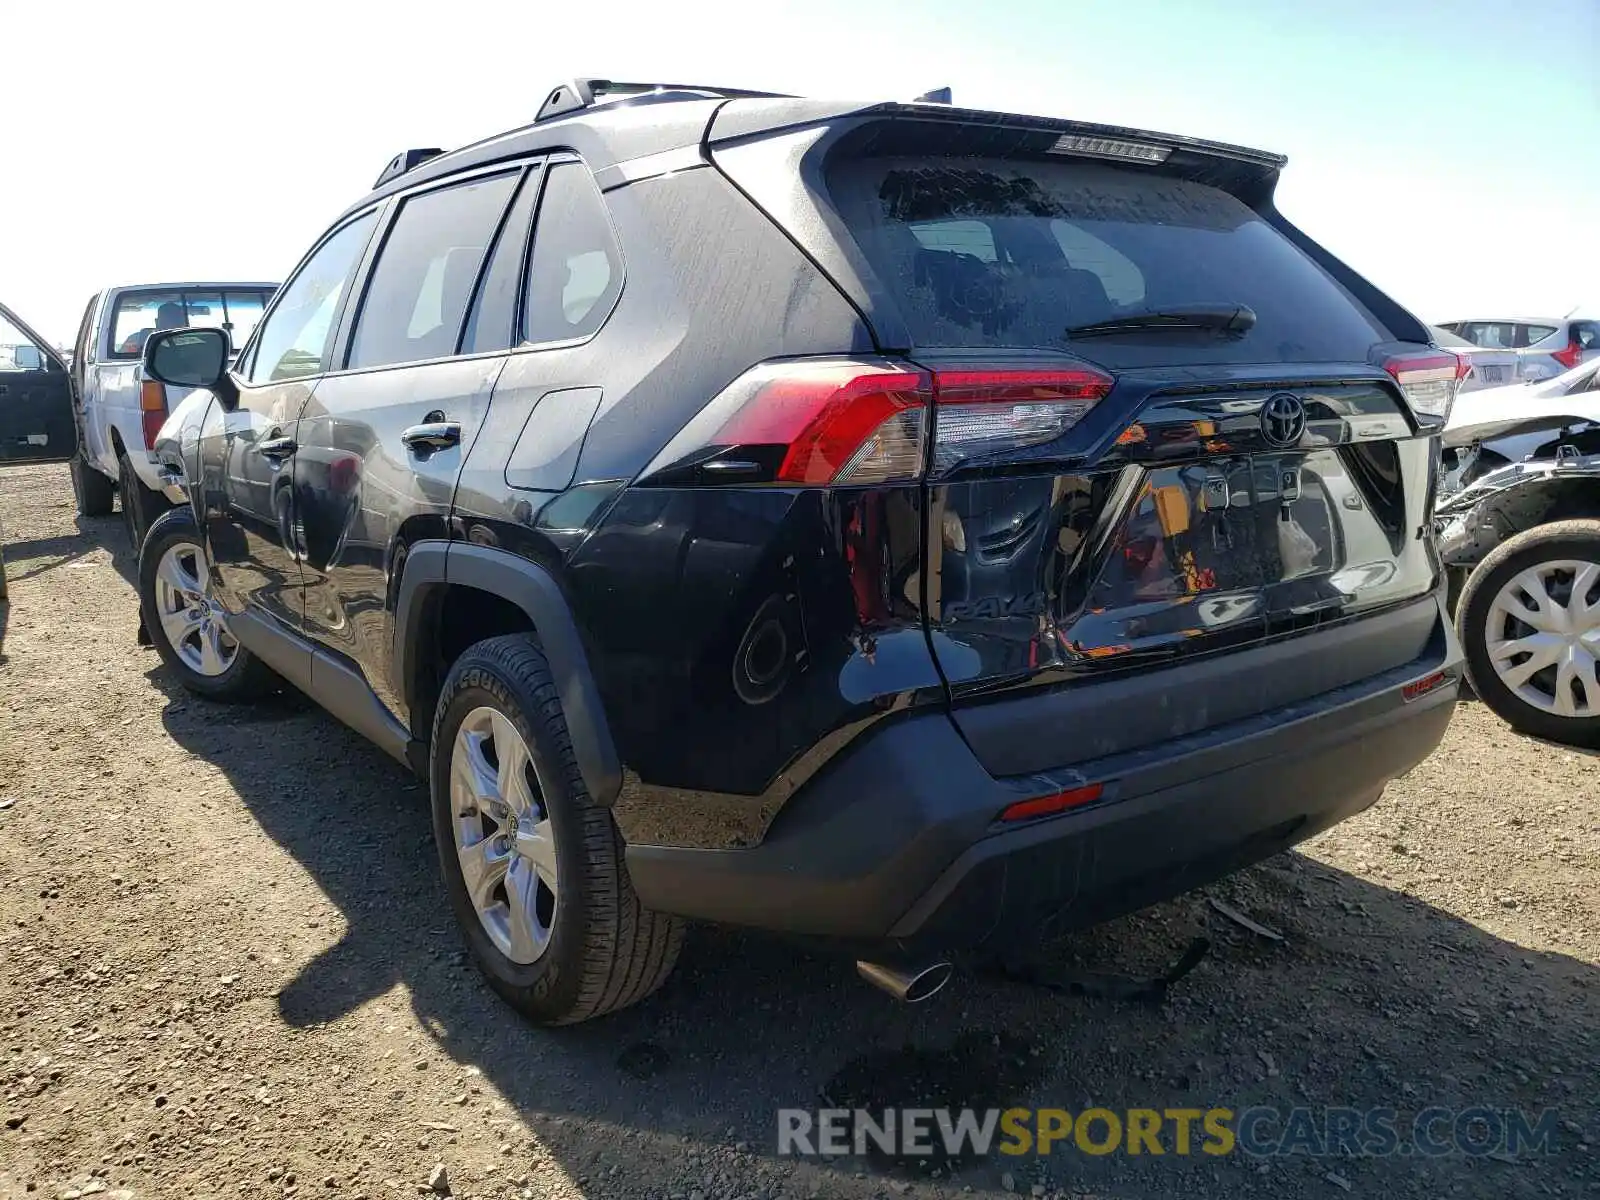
[829,158,1389,366]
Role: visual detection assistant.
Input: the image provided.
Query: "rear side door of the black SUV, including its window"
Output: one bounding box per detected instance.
[294,166,524,714]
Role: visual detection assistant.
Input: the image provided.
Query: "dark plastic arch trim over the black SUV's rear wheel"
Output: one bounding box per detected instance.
[390,541,622,806]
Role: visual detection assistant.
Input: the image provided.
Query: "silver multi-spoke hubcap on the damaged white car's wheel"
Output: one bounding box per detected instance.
[1483,558,1600,718]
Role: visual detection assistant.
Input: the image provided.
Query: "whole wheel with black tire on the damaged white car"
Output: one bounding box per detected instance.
[1456,520,1600,746]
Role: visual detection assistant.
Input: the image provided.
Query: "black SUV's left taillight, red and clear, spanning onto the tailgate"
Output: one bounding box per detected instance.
[643,358,1112,485]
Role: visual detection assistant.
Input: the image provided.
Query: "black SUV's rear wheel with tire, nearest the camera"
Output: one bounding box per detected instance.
[430,634,683,1026]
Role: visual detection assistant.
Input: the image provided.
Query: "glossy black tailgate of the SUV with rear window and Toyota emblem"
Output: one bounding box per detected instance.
[736,129,1456,774]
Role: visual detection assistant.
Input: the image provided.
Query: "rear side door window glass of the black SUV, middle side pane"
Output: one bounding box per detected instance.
[347,174,517,366]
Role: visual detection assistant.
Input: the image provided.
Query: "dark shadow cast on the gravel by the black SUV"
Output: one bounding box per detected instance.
[150,669,1600,1198]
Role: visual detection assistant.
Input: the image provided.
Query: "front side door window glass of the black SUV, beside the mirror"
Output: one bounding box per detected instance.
[248,213,378,384]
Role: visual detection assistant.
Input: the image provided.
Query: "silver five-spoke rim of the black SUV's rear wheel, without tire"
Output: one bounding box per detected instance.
[450,707,557,965]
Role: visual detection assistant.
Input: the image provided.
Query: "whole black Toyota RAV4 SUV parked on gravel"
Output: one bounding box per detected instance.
[141,80,1461,1022]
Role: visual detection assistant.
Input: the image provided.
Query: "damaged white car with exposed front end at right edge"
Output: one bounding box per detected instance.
[1434,362,1600,746]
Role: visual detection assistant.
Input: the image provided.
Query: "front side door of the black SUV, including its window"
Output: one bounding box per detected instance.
[190,211,378,630]
